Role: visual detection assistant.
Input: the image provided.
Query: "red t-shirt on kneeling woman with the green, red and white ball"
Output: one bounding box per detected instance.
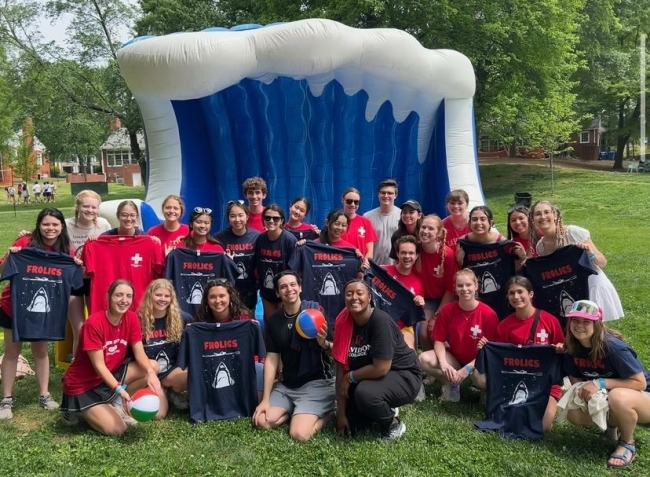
[63,310,142,396]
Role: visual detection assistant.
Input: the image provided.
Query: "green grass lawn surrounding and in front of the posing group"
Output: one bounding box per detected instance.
[0,164,650,477]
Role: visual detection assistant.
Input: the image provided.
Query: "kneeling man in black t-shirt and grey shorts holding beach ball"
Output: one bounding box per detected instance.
[253,270,335,441]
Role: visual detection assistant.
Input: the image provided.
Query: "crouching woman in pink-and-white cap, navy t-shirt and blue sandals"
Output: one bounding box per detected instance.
[564,300,650,467]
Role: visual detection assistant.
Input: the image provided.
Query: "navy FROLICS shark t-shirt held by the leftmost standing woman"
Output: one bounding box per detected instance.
[1,247,83,341]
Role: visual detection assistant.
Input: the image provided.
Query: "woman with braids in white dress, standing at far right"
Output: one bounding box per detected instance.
[530,201,624,321]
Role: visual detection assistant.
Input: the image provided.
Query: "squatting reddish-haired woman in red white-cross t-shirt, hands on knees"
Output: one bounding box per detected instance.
[420,268,499,402]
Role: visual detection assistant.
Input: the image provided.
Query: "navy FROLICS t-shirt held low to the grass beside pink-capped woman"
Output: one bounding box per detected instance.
[475,343,562,439]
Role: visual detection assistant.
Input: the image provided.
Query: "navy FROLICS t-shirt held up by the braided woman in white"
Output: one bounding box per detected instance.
[519,245,597,329]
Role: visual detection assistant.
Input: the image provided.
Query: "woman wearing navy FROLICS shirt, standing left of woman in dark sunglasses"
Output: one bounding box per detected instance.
[215,200,260,310]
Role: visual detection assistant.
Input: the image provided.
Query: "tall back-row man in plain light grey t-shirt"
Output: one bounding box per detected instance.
[363,179,400,265]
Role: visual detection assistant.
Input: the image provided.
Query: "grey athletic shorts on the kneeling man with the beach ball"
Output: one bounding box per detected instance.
[269,378,335,417]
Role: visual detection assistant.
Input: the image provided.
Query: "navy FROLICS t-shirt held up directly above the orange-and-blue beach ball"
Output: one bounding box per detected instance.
[289,242,361,330]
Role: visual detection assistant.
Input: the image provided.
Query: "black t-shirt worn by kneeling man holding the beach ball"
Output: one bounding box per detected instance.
[264,309,333,389]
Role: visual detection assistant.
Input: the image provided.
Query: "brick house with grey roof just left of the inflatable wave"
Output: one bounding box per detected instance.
[101,119,146,187]
